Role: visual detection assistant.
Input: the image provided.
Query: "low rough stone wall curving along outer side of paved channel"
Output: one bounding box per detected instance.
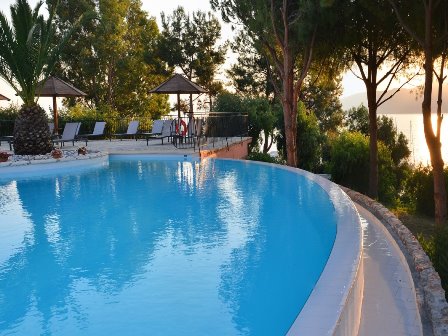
[341,187,448,336]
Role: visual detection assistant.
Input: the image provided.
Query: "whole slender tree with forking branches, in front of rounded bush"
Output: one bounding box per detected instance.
[344,0,415,198]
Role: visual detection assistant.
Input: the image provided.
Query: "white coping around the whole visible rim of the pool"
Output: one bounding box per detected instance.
[0,154,364,336]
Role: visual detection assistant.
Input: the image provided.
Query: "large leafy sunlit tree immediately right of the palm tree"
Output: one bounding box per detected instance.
[47,0,169,118]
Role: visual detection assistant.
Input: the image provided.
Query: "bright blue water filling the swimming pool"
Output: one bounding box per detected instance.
[0,157,336,336]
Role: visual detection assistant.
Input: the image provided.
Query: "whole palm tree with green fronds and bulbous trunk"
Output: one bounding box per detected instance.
[0,0,82,155]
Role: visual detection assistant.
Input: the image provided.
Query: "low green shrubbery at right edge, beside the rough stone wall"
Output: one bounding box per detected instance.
[417,227,448,297]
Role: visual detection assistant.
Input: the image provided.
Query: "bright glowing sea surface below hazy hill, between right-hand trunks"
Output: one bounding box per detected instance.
[386,113,448,165]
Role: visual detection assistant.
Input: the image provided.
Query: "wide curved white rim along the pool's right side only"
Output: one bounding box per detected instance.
[233,162,364,336]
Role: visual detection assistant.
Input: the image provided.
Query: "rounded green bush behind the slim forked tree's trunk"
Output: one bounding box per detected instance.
[330,132,397,204]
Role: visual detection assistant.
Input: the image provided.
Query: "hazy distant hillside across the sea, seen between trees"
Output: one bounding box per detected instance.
[341,85,448,114]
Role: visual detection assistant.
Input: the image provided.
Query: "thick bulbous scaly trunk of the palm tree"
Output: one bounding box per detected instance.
[14,105,53,155]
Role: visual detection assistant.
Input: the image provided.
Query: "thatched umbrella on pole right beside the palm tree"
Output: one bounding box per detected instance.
[36,76,87,134]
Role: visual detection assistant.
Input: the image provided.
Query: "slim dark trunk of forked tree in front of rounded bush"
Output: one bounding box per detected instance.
[366,85,379,199]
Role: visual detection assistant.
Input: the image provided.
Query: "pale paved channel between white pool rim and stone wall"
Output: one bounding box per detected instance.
[356,205,423,336]
